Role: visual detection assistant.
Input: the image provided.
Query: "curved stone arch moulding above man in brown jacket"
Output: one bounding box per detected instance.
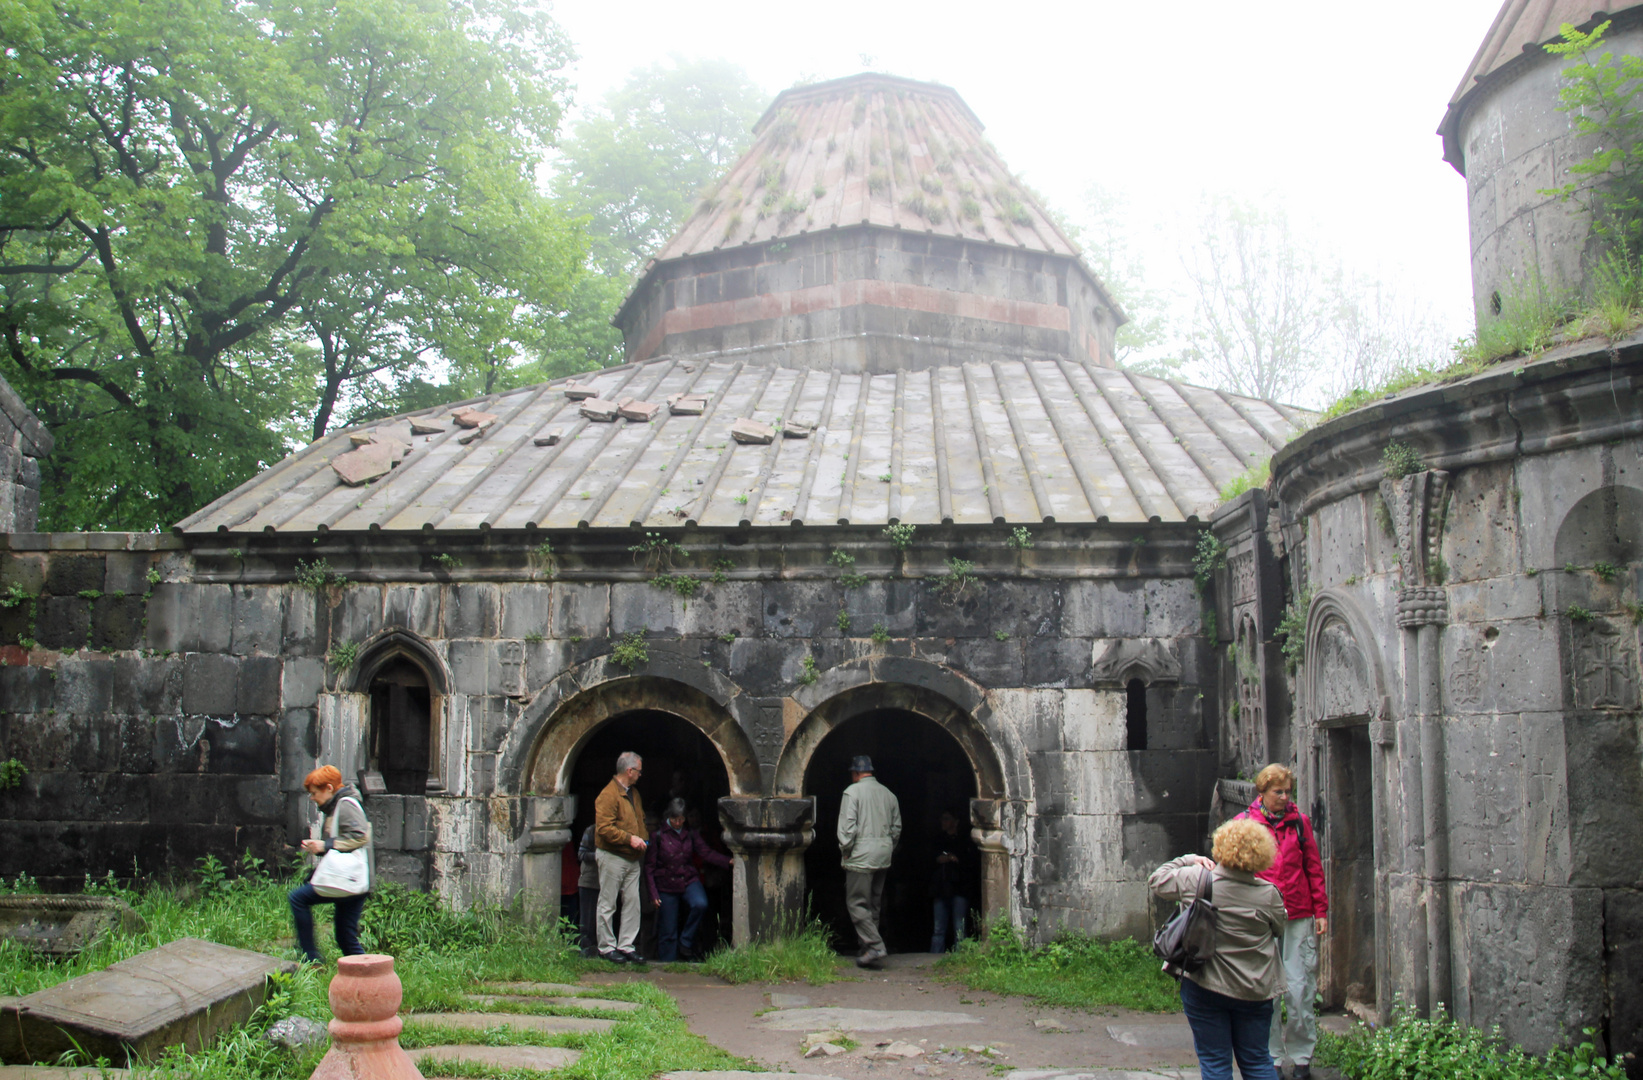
[496,658,762,796]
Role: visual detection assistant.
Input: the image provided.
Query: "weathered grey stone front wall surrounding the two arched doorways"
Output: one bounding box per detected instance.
[0,526,1214,935]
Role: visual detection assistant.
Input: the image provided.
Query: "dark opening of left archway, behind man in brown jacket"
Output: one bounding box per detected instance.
[570,710,731,957]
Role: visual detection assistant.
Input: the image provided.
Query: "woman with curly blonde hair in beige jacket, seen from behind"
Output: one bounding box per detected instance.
[1147,819,1288,1080]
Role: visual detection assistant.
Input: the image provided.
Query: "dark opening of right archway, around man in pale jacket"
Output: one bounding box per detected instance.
[805,708,981,955]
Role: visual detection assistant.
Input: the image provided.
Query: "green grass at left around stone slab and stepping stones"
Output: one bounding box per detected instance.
[0,863,749,1080]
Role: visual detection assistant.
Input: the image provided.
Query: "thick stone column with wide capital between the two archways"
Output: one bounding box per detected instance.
[720,796,817,945]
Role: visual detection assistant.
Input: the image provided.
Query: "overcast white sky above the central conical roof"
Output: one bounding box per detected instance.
[554,0,1500,345]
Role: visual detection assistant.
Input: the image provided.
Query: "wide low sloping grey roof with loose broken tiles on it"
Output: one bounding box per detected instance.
[177,357,1308,533]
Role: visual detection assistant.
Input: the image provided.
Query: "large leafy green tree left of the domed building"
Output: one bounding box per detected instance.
[0,0,585,528]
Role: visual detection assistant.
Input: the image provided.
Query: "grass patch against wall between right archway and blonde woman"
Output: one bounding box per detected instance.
[938,921,1181,1013]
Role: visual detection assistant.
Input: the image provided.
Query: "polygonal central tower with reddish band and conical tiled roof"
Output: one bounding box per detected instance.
[616,74,1124,373]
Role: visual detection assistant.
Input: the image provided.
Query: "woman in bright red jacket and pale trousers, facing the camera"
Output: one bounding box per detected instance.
[1239,764,1329,1080]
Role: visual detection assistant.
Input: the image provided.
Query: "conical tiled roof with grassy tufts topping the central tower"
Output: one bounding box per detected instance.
[657,74,1078,261]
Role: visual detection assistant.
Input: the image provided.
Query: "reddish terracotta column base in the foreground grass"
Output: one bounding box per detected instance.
[312,953,422,1080]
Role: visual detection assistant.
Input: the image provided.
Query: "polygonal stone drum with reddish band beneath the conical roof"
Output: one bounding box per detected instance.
[619,227,1117,372]
